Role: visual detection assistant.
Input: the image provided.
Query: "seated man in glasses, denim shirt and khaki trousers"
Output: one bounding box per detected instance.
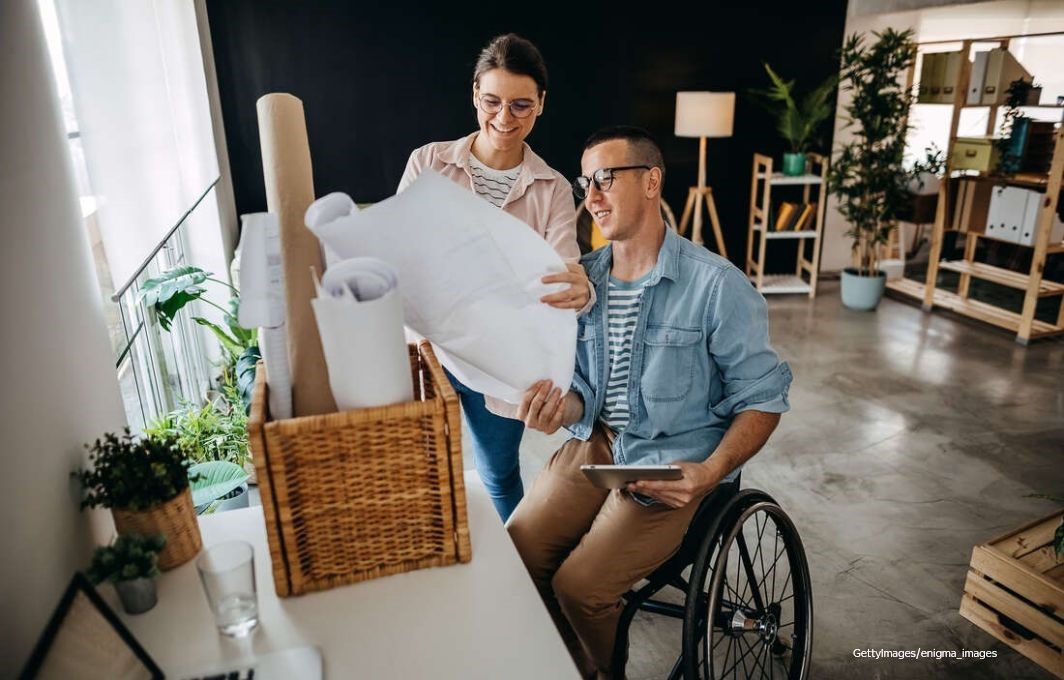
[508,127,792,678]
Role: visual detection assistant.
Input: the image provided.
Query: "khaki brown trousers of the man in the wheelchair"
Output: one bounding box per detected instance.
[506,426,698,678]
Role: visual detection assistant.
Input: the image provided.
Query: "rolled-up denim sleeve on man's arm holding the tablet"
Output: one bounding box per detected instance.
[705,267,792,419]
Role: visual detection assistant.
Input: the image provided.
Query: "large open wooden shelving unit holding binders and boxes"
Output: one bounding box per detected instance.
[886,33,1064,345]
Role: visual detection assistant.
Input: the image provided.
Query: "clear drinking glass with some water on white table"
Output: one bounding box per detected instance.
[196,541,259,637]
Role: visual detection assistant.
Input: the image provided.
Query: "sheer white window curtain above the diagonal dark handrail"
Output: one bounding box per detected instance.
[56,0,218,289]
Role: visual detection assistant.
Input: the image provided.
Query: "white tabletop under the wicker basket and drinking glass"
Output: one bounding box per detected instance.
[117,472,579,680]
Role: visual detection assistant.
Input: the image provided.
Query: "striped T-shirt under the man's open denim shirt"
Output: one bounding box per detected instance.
[600,272,650,433]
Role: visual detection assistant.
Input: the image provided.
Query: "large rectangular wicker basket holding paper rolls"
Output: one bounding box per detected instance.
[248,343,471,597]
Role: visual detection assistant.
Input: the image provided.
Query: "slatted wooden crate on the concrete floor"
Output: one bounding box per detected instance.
[961,511,1064,678]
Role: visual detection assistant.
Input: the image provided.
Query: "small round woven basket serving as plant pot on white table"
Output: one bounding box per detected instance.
[111,488,203,571]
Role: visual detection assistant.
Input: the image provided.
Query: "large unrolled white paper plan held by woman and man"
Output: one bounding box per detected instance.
[306,170,577,403]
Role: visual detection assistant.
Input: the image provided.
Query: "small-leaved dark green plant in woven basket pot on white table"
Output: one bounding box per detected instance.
[73,428,202,570]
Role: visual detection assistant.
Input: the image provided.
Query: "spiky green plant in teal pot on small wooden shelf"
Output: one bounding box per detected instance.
[750,64,838,176]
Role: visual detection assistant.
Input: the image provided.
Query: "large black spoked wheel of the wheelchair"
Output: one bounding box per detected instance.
[683,490,813,680]
